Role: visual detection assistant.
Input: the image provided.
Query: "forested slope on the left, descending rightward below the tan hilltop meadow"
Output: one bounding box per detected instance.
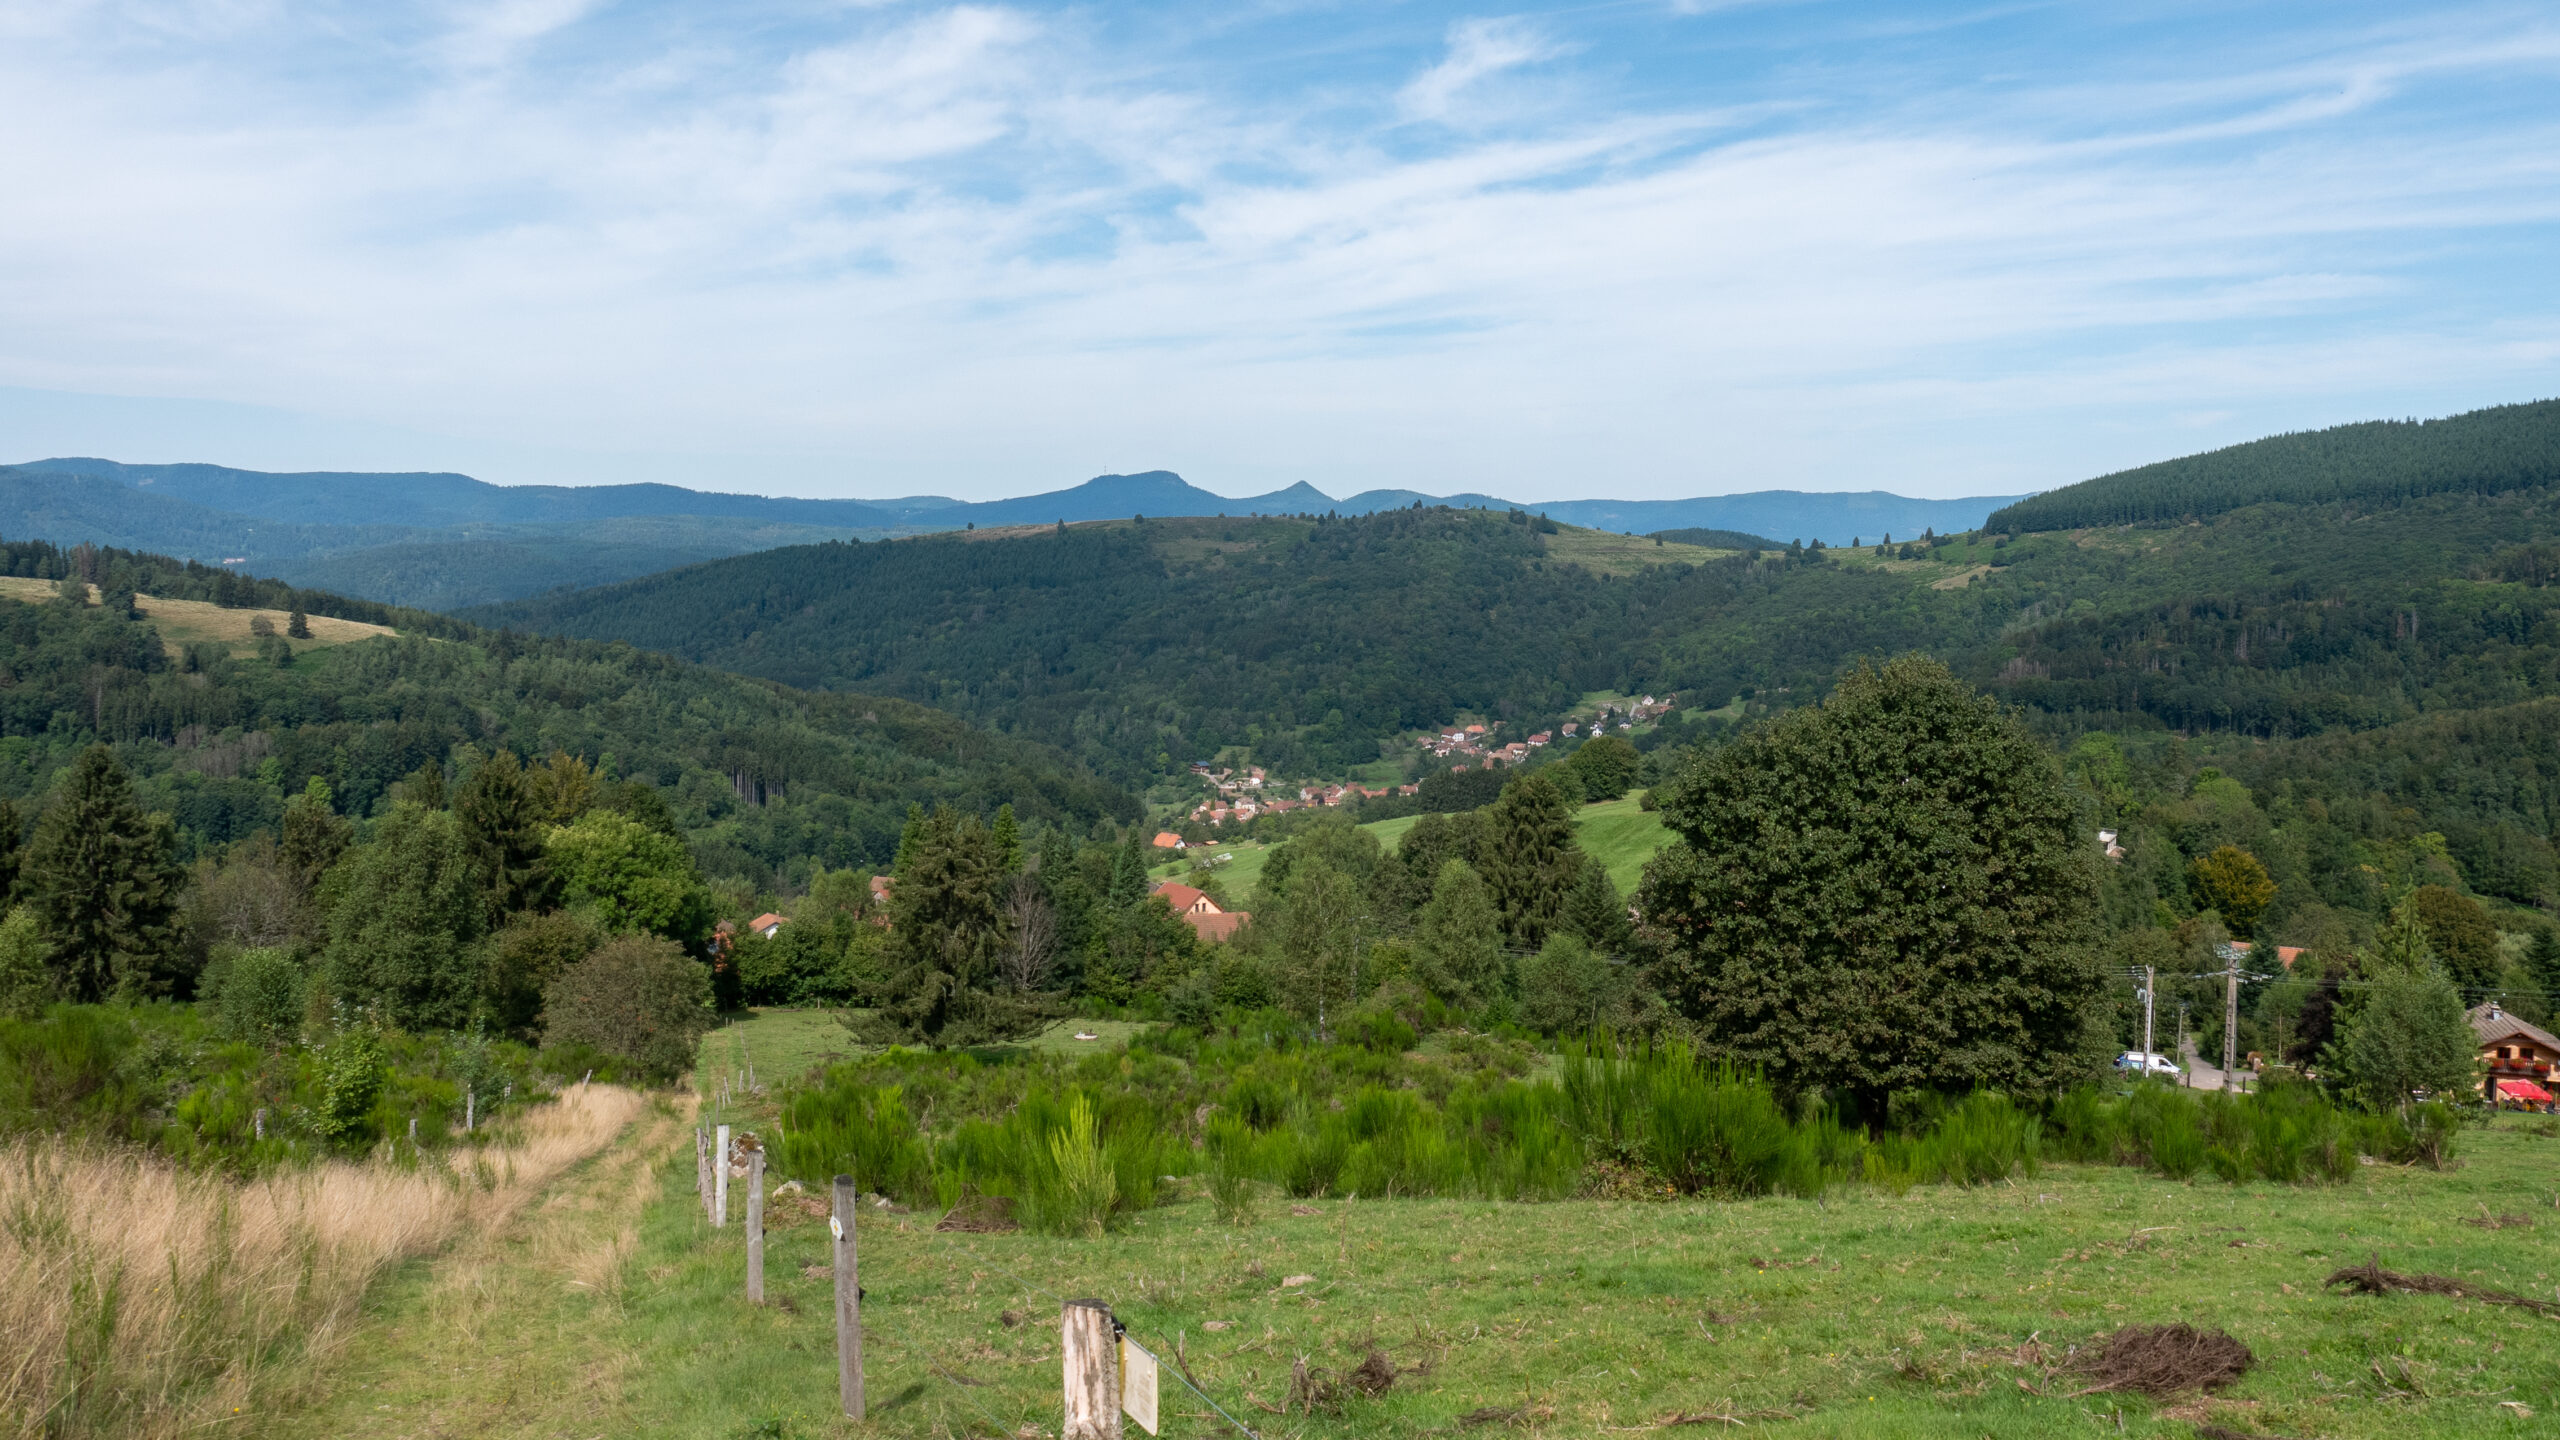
[0,532,1134,884]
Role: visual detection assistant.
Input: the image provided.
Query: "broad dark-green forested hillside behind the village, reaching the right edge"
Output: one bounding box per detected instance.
[481,410,2560,781]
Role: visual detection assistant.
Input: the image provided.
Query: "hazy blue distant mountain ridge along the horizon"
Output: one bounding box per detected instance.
[0,456,2012,610]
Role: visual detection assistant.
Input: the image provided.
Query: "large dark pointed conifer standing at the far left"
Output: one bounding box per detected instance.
[20,746,184,999]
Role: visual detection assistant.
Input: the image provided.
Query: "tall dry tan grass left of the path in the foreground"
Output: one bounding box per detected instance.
[0,1086,645,1437]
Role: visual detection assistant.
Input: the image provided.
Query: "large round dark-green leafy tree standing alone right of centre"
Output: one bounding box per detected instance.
[1636,659,2102,1115]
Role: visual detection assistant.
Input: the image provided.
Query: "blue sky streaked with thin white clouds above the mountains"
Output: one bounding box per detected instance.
[0,0,2560,500]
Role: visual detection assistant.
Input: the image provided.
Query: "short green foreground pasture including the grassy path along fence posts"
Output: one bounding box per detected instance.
[282,1076,2560,1440]
